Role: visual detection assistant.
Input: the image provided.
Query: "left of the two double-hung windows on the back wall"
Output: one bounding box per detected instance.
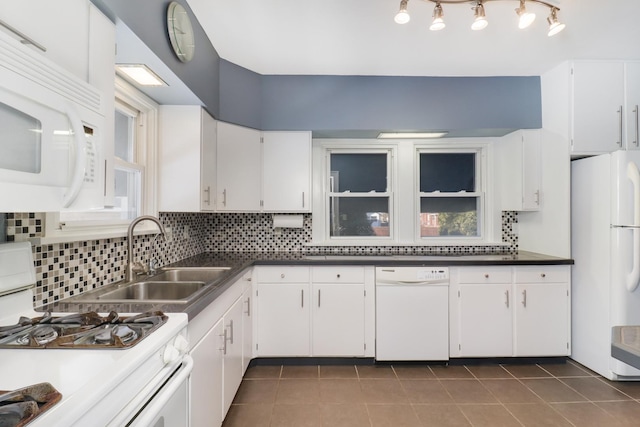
[327,150,391,238]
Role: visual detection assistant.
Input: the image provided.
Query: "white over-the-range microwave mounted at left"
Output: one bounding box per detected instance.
[0,33,105,212]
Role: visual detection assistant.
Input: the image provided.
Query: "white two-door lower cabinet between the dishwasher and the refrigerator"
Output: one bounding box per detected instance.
[450,266,571,357]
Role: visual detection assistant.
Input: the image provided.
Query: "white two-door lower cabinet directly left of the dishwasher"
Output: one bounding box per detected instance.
[256,266,375,357]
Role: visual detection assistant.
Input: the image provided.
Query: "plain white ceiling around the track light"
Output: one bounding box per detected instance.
[187,0,640,76]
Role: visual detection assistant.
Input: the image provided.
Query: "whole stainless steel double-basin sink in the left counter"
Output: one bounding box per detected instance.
[65,267,231,304]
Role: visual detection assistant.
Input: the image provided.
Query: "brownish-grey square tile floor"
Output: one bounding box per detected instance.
[223,361,640,427]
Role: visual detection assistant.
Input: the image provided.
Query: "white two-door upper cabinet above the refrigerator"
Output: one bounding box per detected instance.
[541,60,640,156]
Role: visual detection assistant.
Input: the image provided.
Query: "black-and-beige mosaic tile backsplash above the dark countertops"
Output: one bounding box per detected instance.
[5,212,518,307]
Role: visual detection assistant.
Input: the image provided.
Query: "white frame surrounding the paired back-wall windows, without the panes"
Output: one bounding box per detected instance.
[308,137,502,246]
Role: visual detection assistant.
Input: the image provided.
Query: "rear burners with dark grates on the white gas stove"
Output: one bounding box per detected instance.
[0,311,167,349]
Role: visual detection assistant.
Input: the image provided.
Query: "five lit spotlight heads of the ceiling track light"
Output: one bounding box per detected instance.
[395,0,565,37]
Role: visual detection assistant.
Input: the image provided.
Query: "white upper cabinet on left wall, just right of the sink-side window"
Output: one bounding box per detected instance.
[158,105,216,212]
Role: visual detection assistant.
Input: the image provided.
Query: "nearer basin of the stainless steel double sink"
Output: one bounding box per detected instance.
[96,281,206,301]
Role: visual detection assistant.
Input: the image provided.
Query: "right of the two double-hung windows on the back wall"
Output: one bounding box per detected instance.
[418,150,482,239]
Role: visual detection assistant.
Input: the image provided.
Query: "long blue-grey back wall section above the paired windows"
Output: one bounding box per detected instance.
[258,75,542,131]
